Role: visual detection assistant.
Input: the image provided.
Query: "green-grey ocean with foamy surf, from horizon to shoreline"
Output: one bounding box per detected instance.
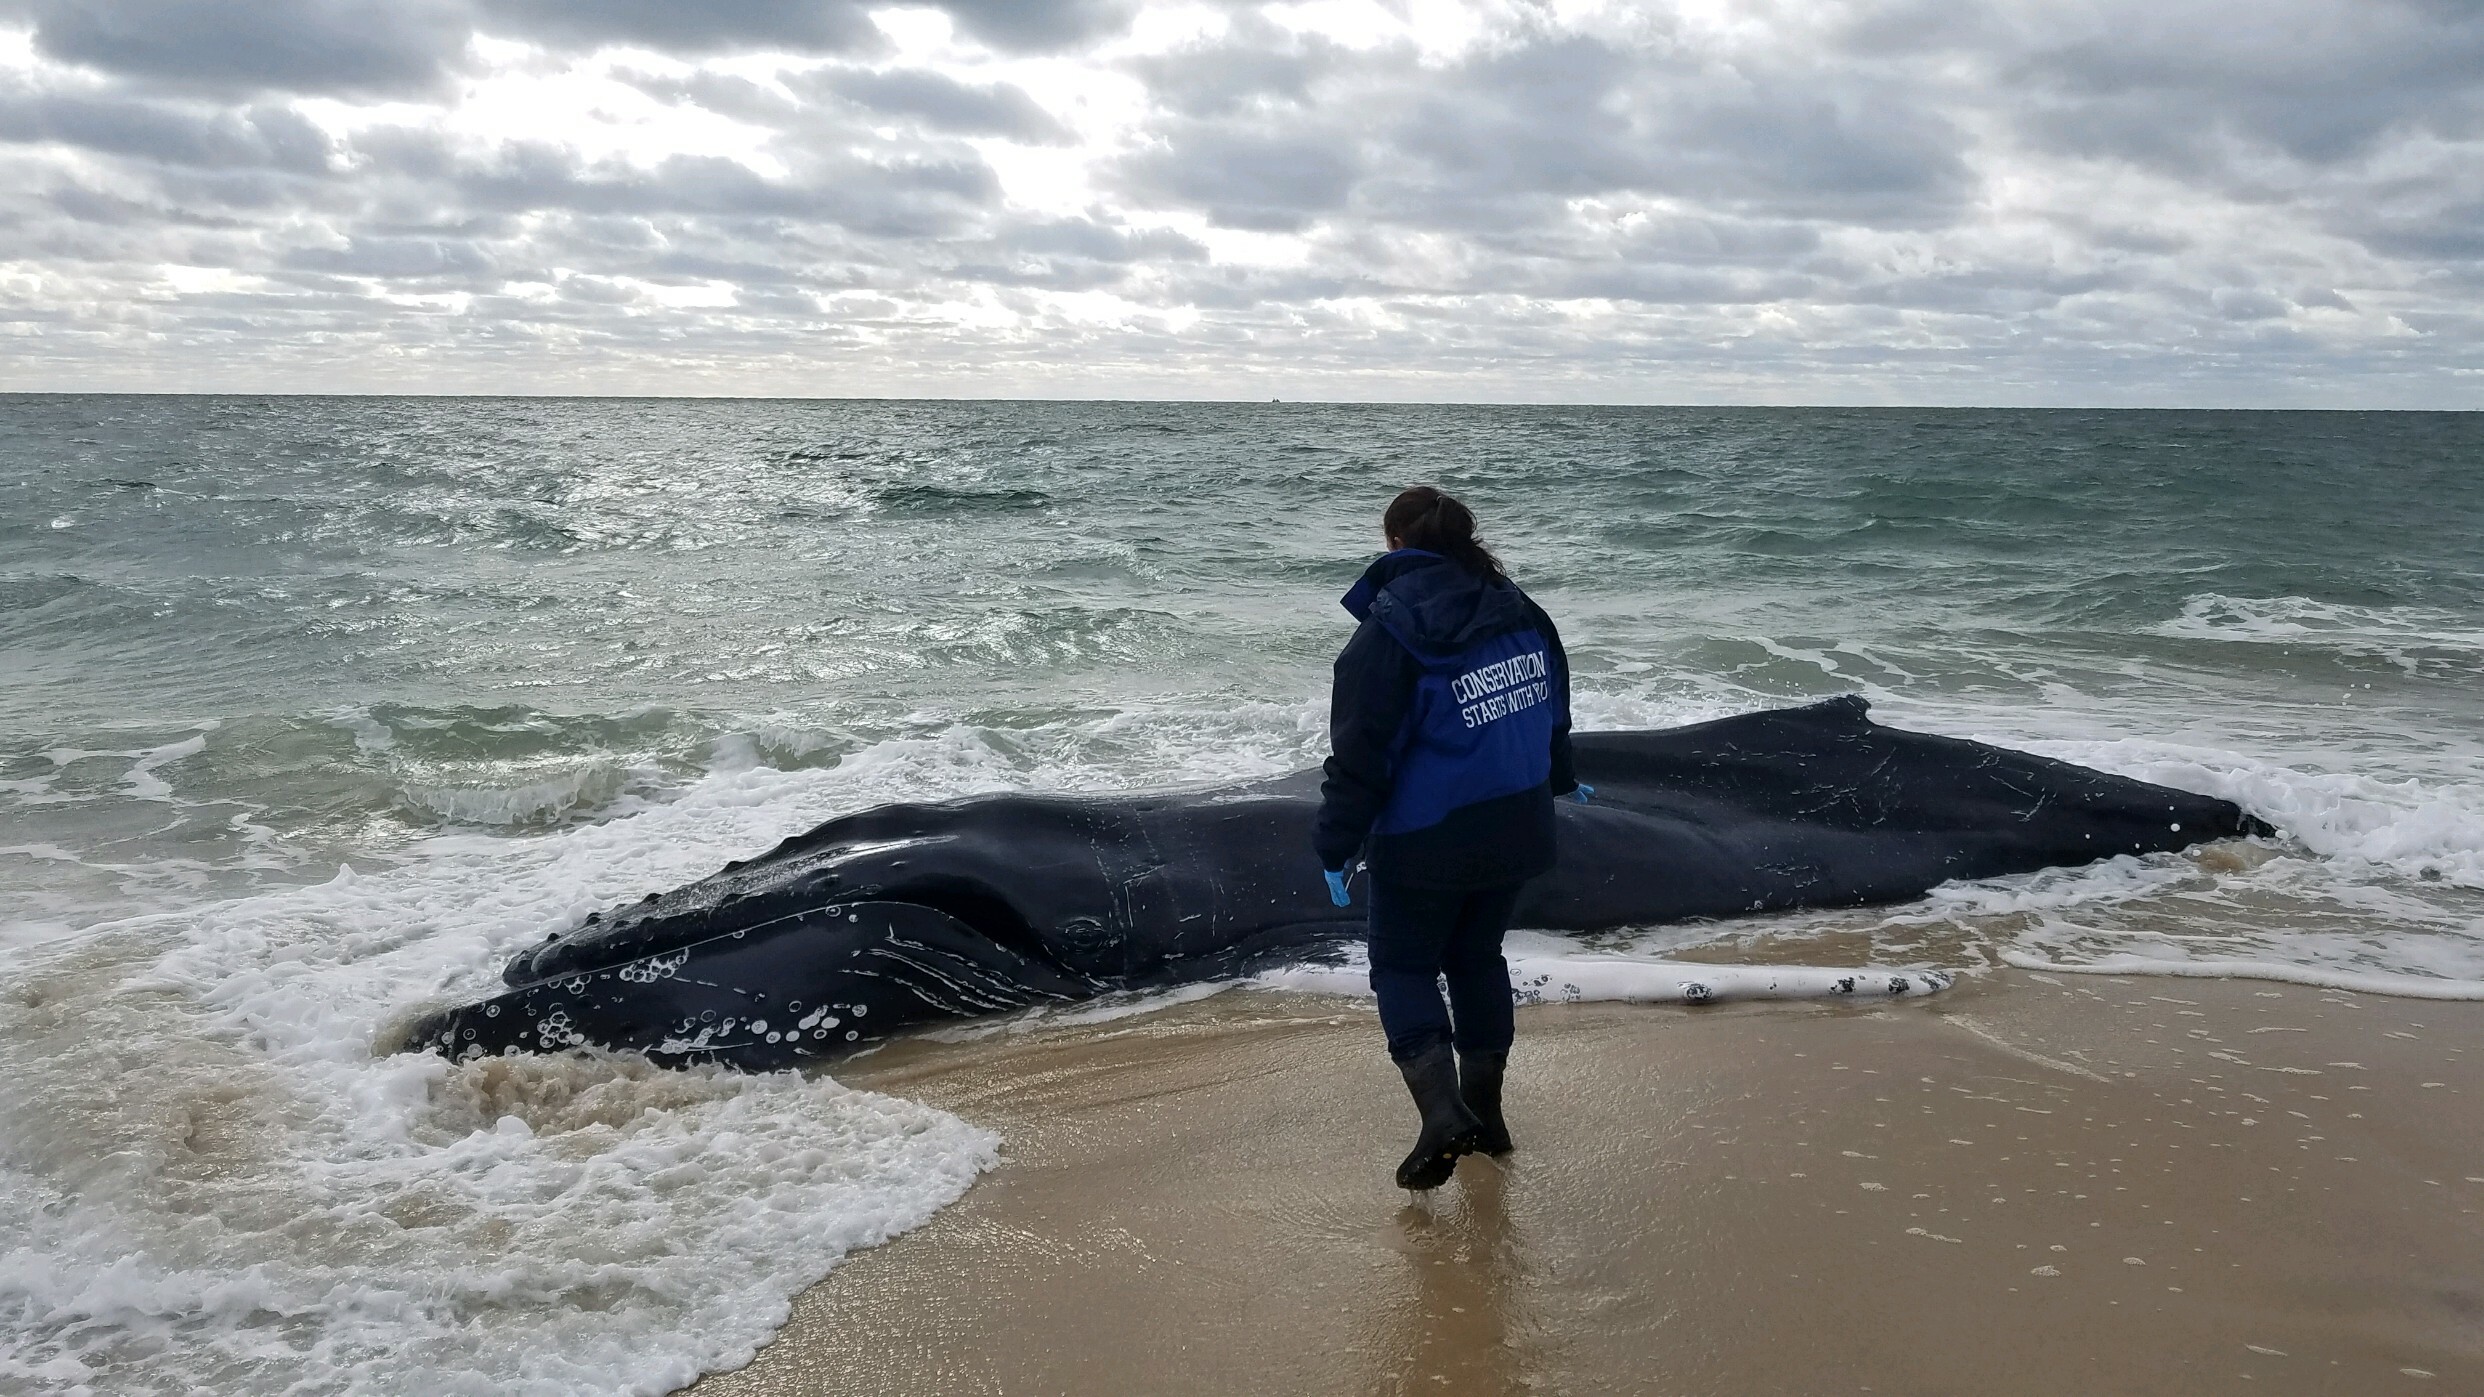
[0,395,2484,1395]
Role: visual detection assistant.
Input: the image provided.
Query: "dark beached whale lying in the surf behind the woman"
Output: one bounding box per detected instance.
[410,696,2270,1069]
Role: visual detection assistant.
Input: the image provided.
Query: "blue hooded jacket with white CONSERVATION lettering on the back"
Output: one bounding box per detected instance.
[1314,549,1577,887]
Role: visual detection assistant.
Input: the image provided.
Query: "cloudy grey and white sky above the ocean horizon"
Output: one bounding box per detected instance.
[0,0,2484,408]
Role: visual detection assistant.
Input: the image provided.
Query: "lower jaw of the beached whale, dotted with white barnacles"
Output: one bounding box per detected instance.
[407,902,1098,1069]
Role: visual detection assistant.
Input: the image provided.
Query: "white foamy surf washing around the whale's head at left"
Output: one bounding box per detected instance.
[0,733,1063,1395]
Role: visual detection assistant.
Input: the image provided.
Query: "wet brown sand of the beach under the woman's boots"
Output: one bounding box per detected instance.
[693,972,2484,1397]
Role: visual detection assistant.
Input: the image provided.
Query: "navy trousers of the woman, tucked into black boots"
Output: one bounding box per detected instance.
[1371,880,1518,1061]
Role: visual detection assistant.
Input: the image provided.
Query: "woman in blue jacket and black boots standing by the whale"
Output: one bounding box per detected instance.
[1314,485,1590,1188]
